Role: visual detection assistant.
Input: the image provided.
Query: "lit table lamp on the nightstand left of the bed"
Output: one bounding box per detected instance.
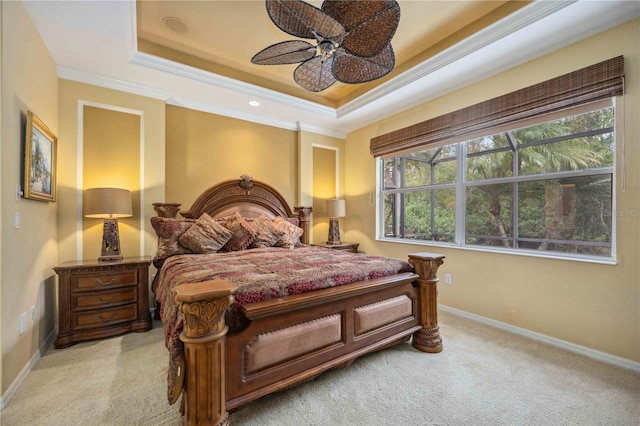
[84,188,133,261]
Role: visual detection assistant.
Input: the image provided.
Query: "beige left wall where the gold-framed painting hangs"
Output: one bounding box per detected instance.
[0,1,60,395]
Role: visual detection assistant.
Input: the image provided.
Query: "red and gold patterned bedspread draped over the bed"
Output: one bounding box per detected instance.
[158,246,413,401]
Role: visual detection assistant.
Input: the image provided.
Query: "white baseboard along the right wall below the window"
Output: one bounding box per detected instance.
[438,304,640,373]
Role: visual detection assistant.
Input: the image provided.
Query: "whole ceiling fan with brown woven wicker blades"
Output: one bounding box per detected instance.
[251,0,400,92]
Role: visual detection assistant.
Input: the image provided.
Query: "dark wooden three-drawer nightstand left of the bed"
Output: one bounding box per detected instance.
[53,257,152,349]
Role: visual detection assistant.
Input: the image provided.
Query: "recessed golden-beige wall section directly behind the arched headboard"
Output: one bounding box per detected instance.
[162,106,298,210]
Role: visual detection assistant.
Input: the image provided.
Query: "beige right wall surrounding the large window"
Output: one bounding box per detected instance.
[344,20,640,361]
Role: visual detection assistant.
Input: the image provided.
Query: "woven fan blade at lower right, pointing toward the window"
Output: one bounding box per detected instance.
[332,44,396,84]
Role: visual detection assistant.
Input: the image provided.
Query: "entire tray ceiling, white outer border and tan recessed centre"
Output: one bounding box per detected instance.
[22,0,640,137]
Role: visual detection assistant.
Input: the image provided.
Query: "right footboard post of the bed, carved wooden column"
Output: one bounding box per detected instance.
[409,253,444,353]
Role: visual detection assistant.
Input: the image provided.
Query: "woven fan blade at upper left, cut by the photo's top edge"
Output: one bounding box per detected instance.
[266,0,345,42]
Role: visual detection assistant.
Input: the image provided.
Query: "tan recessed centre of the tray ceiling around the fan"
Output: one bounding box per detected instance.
[137,0,516,107]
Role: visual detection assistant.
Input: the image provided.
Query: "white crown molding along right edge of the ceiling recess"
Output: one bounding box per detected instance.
[336,0,577,118]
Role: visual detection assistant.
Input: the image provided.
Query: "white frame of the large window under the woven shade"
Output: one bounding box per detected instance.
[376,97,624,265]
